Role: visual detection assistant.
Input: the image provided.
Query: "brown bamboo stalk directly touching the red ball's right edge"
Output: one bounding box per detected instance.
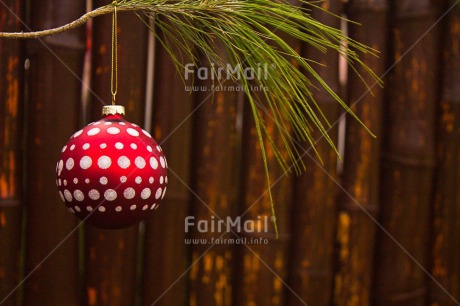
[142,19,193,306]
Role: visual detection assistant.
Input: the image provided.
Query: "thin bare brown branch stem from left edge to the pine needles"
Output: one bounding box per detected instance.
[0,5,142,39]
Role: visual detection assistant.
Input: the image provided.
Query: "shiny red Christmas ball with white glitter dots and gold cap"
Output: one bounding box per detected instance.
[56,105,168,229]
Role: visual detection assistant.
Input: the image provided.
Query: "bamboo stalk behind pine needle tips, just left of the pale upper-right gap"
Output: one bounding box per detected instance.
[288,0,342,305]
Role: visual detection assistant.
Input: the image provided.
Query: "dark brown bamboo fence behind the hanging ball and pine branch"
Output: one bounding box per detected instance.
[0,0,460,306]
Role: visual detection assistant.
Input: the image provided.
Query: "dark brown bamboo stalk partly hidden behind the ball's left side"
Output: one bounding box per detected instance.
[25,0,85,306]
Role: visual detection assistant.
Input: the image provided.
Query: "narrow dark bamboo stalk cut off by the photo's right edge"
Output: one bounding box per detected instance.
[430,1,460,306]
